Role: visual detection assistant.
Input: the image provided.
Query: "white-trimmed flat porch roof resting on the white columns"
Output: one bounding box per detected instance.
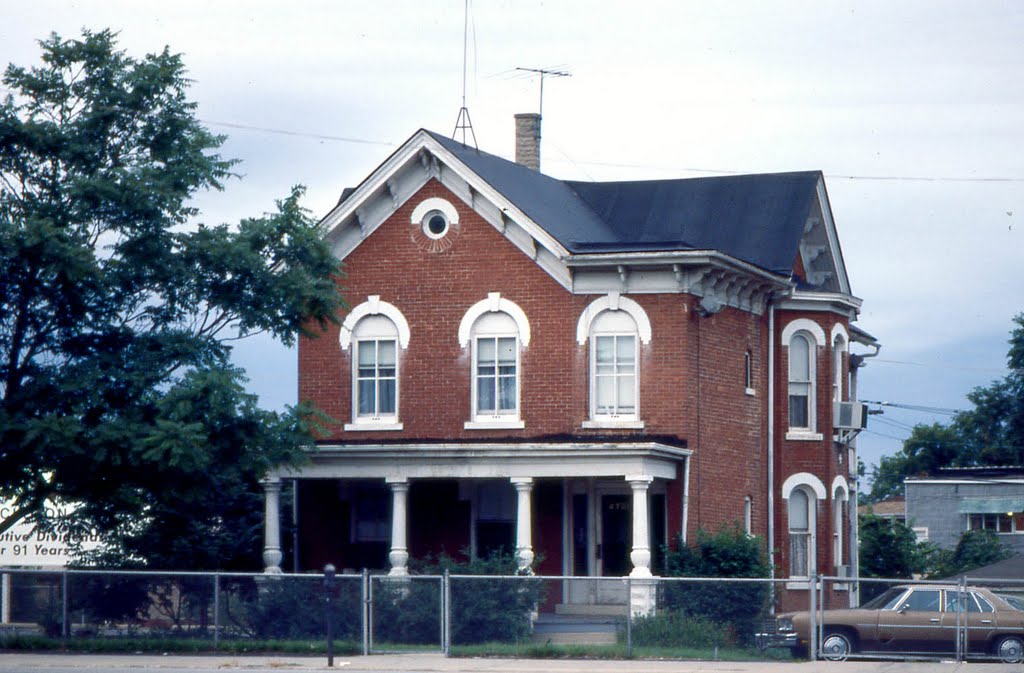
[271,441,692,481]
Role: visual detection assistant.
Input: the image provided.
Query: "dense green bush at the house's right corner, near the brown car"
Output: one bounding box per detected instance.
[659,525,771,643]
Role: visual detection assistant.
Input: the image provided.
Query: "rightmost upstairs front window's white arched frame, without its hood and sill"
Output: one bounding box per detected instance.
[590,310,640,421]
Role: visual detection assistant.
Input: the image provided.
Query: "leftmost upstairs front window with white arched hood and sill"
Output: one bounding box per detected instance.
[340,295,410,430]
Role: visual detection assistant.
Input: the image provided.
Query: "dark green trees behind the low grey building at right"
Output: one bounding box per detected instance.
[869,313,1024,502]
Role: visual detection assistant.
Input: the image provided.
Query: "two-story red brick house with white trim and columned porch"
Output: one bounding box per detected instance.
[264,116,874,611]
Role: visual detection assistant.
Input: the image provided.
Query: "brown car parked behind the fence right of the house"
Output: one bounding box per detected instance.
[775,585,1024,663]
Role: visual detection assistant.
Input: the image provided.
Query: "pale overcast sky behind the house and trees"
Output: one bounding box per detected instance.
[0,0,1024,473]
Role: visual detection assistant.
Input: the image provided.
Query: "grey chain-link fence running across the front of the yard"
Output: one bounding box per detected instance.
[0,570,1024,661]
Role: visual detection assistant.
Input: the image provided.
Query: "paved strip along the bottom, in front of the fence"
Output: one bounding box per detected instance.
[0,654,1022,673]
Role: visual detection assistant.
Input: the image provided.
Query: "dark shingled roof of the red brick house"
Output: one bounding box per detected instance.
[427,131,821,277]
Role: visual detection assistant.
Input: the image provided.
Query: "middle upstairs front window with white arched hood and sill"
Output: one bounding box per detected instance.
[459,292,529,429]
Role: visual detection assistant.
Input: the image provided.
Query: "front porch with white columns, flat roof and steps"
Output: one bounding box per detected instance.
[263,443,689,614]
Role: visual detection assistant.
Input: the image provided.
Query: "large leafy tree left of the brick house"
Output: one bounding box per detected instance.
[0,31,342,565]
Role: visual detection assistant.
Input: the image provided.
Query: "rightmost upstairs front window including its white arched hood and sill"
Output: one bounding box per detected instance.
[577,292,650,428]
